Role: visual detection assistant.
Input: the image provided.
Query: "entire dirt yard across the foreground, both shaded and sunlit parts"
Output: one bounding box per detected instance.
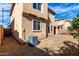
[0,35,79,56]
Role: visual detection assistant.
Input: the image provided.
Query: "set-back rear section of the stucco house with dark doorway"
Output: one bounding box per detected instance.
[48,8,57,35]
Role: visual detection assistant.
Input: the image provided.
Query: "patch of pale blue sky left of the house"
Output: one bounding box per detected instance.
[0,3,11,27]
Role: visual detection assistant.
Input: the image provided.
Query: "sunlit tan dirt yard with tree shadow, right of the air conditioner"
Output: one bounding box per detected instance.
[37,35,79,56]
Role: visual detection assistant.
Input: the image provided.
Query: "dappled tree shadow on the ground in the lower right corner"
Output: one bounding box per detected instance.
[51,41,79,56]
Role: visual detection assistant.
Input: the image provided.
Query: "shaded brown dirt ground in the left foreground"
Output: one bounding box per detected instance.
[0,37,49,56]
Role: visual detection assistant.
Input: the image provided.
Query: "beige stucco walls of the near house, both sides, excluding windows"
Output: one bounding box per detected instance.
[11,3,48,42]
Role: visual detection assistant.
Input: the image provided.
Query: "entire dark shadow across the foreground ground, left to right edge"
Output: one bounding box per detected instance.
[0,37,79,56]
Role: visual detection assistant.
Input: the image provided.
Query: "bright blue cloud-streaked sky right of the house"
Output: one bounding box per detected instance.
[48,3,79,20]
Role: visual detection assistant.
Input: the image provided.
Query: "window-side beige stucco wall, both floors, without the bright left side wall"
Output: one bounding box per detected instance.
[22,3,48,42]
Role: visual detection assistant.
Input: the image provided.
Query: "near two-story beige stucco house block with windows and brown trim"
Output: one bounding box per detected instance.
[10,3,48,43]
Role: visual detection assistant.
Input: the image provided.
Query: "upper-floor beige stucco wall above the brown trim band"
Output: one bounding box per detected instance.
[23,3,48,19]
